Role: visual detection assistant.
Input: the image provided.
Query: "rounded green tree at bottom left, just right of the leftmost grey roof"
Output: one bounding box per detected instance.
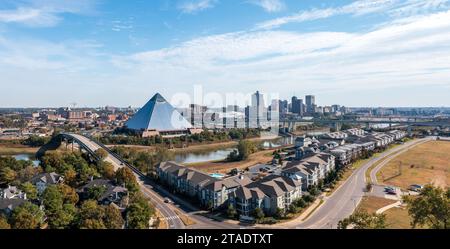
[11,202,44,229]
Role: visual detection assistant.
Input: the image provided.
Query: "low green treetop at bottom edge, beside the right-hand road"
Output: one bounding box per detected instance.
[338,210,386,229]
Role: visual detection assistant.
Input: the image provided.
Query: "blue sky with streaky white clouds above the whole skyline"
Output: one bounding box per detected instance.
[0,0,450,107]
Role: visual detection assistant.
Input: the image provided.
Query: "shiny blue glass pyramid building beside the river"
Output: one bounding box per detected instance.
[125,93,192,131]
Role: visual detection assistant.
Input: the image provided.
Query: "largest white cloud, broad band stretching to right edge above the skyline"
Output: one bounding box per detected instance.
[108,11,450,104]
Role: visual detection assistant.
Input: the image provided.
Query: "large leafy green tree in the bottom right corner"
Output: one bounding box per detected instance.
[405,185,450,229]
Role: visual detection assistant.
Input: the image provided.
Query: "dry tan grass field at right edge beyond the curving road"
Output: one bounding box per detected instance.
[377,141,450,189]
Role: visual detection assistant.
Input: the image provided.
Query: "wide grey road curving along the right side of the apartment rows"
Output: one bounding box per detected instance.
[287,138,431,229]
